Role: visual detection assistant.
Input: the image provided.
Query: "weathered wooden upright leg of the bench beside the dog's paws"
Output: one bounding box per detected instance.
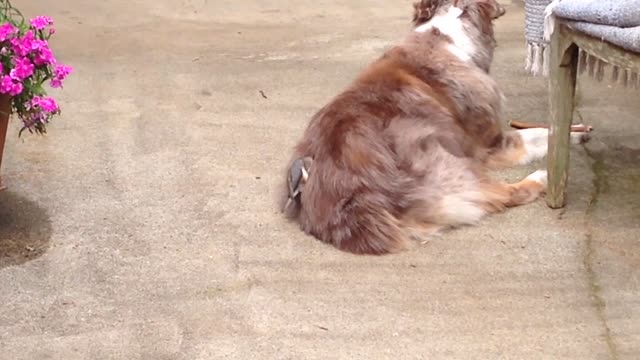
[546,26,578,209]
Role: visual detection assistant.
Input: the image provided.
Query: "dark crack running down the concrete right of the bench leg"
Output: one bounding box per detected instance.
[583,146,619,360]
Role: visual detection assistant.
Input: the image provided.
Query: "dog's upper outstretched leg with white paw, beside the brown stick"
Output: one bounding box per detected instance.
[485,128,589,169]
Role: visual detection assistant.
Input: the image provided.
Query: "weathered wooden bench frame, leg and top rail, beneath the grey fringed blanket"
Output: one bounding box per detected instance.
[546,19,640,209]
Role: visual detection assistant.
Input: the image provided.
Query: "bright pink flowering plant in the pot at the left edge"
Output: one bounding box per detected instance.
[0,0,72,190]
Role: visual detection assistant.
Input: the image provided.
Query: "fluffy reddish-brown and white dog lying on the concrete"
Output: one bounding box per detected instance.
[281,0,584,254]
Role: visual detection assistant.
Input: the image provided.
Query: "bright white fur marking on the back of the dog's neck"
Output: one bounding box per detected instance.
[414,6,476,61]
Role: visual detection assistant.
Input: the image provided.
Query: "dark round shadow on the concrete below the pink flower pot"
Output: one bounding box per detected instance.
[0,191,52,269]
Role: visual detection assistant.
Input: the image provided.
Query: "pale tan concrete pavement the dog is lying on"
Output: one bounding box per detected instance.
[0,0,640,360]
